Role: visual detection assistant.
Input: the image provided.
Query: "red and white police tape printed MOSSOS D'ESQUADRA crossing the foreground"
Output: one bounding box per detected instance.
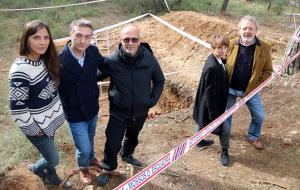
[115,51,300,190]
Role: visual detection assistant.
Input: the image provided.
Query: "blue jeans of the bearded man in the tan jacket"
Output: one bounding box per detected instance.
[226,88,265,140]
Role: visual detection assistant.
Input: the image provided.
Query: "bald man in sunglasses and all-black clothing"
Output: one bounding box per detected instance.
[96,25,165,186]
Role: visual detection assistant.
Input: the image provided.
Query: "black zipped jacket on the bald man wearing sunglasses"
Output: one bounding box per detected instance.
[99,43,165,118]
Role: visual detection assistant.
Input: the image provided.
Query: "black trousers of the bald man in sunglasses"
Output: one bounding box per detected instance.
[103,115,147,171]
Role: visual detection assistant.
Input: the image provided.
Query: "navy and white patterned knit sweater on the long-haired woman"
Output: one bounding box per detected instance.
[9,58,65,136]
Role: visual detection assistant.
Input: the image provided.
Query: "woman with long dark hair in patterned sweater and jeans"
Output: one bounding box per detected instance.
[9,20,70,186]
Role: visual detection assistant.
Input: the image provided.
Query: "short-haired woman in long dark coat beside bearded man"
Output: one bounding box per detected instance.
[193,35,230,165]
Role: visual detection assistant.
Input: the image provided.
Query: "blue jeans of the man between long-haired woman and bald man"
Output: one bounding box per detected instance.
[69,114,98,168]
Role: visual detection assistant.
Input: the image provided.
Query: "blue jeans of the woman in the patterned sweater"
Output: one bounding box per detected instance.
[26,135,59,174]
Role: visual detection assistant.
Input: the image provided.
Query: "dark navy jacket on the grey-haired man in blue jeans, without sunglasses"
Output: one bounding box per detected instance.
[58,42,104,123]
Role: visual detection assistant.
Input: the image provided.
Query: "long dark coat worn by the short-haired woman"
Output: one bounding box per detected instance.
[193,54,228,134]
